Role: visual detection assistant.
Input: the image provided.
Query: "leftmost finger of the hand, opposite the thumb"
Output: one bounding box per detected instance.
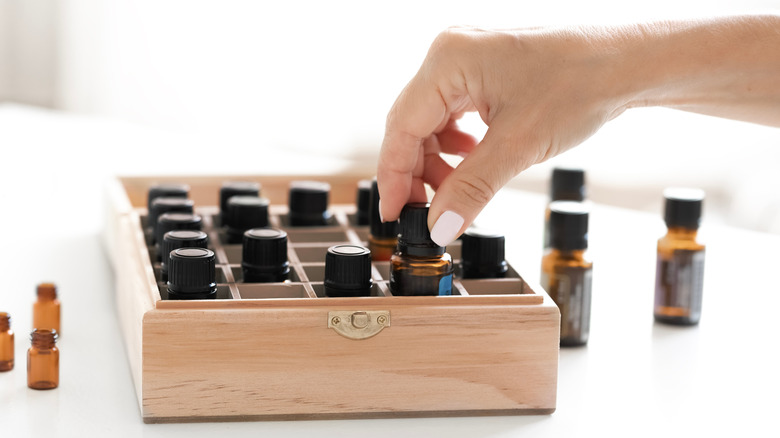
[376,73,447,221]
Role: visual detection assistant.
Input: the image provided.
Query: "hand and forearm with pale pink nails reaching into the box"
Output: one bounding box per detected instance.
[377,15,780,246]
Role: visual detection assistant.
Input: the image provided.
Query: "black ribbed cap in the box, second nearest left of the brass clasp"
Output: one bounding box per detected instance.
[241,228,290,273]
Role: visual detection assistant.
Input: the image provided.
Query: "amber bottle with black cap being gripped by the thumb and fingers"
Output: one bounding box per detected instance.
[390,203,454,296]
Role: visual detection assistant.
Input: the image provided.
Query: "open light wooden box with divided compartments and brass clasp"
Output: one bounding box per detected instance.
[105,176,560,422]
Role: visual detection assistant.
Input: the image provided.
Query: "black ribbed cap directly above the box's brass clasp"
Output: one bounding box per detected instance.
[324,245,373,297]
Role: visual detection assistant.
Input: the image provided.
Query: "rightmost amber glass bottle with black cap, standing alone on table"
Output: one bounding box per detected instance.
[653,188,705,325]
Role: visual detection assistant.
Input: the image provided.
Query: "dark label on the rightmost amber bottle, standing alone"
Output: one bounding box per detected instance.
[655,249,704,320]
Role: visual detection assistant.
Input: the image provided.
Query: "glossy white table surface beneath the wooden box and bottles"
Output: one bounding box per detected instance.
[0,104,780,438]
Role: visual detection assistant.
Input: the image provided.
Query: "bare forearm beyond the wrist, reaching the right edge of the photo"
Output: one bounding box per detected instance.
[616,15,780,126]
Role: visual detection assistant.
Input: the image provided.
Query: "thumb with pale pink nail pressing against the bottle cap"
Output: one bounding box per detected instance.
[428,123,536,246]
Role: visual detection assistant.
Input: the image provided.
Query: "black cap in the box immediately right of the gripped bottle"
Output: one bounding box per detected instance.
[461,227,508,278]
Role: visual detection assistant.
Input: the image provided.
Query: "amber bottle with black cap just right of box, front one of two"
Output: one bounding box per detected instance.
[541,201,593,347]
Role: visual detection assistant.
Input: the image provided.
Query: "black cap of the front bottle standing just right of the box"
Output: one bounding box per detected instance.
[550,201,588,251]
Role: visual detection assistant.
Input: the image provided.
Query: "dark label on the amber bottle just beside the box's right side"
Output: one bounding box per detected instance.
[541,267,593,344]
